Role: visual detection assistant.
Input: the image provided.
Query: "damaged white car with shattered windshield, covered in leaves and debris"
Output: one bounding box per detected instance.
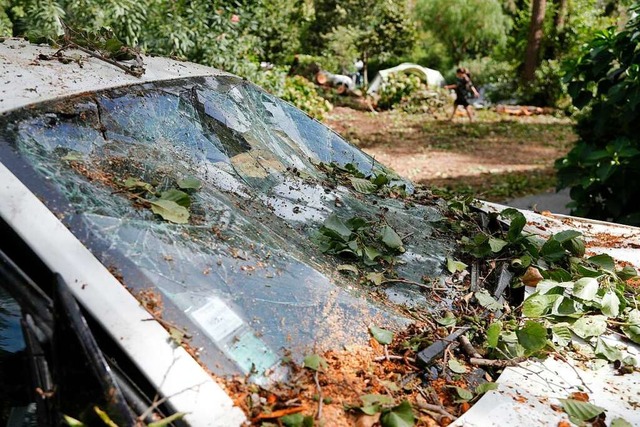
[0,39,640,426]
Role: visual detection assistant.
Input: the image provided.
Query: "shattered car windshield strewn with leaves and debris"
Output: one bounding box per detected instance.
[0,77,452,382]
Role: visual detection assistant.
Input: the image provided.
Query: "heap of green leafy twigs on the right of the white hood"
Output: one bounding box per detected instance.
[442,204,640,365]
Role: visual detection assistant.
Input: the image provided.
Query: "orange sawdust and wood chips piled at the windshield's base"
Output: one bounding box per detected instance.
[217,334,478,427]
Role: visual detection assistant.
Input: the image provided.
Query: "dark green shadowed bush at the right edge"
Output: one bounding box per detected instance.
[556,1,640,225]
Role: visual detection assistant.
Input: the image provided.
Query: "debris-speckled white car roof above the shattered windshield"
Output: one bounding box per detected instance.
[0,38,229,113]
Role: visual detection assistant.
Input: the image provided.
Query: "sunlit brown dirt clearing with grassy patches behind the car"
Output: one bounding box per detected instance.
[325,107,576,201]
